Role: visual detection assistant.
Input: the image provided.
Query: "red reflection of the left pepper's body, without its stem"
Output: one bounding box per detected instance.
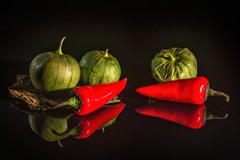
[75,102,126,139]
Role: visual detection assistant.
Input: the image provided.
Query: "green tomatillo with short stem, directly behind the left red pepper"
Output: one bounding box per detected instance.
[79,49,121,84]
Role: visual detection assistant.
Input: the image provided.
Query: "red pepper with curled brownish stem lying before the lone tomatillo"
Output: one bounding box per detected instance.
[136,76,230,104]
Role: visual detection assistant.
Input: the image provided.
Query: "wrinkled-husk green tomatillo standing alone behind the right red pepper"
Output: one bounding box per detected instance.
[151,47,197,82]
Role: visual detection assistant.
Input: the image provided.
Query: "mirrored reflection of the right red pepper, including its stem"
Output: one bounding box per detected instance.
[135,102,228,129]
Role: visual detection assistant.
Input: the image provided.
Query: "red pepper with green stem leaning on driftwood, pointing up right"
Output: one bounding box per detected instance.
[54,78,127,115]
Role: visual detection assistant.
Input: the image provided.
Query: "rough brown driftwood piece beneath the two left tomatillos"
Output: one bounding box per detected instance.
[8,75,121,111]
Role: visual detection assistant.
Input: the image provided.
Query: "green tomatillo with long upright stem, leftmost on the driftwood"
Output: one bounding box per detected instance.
[29,37,81,92]
